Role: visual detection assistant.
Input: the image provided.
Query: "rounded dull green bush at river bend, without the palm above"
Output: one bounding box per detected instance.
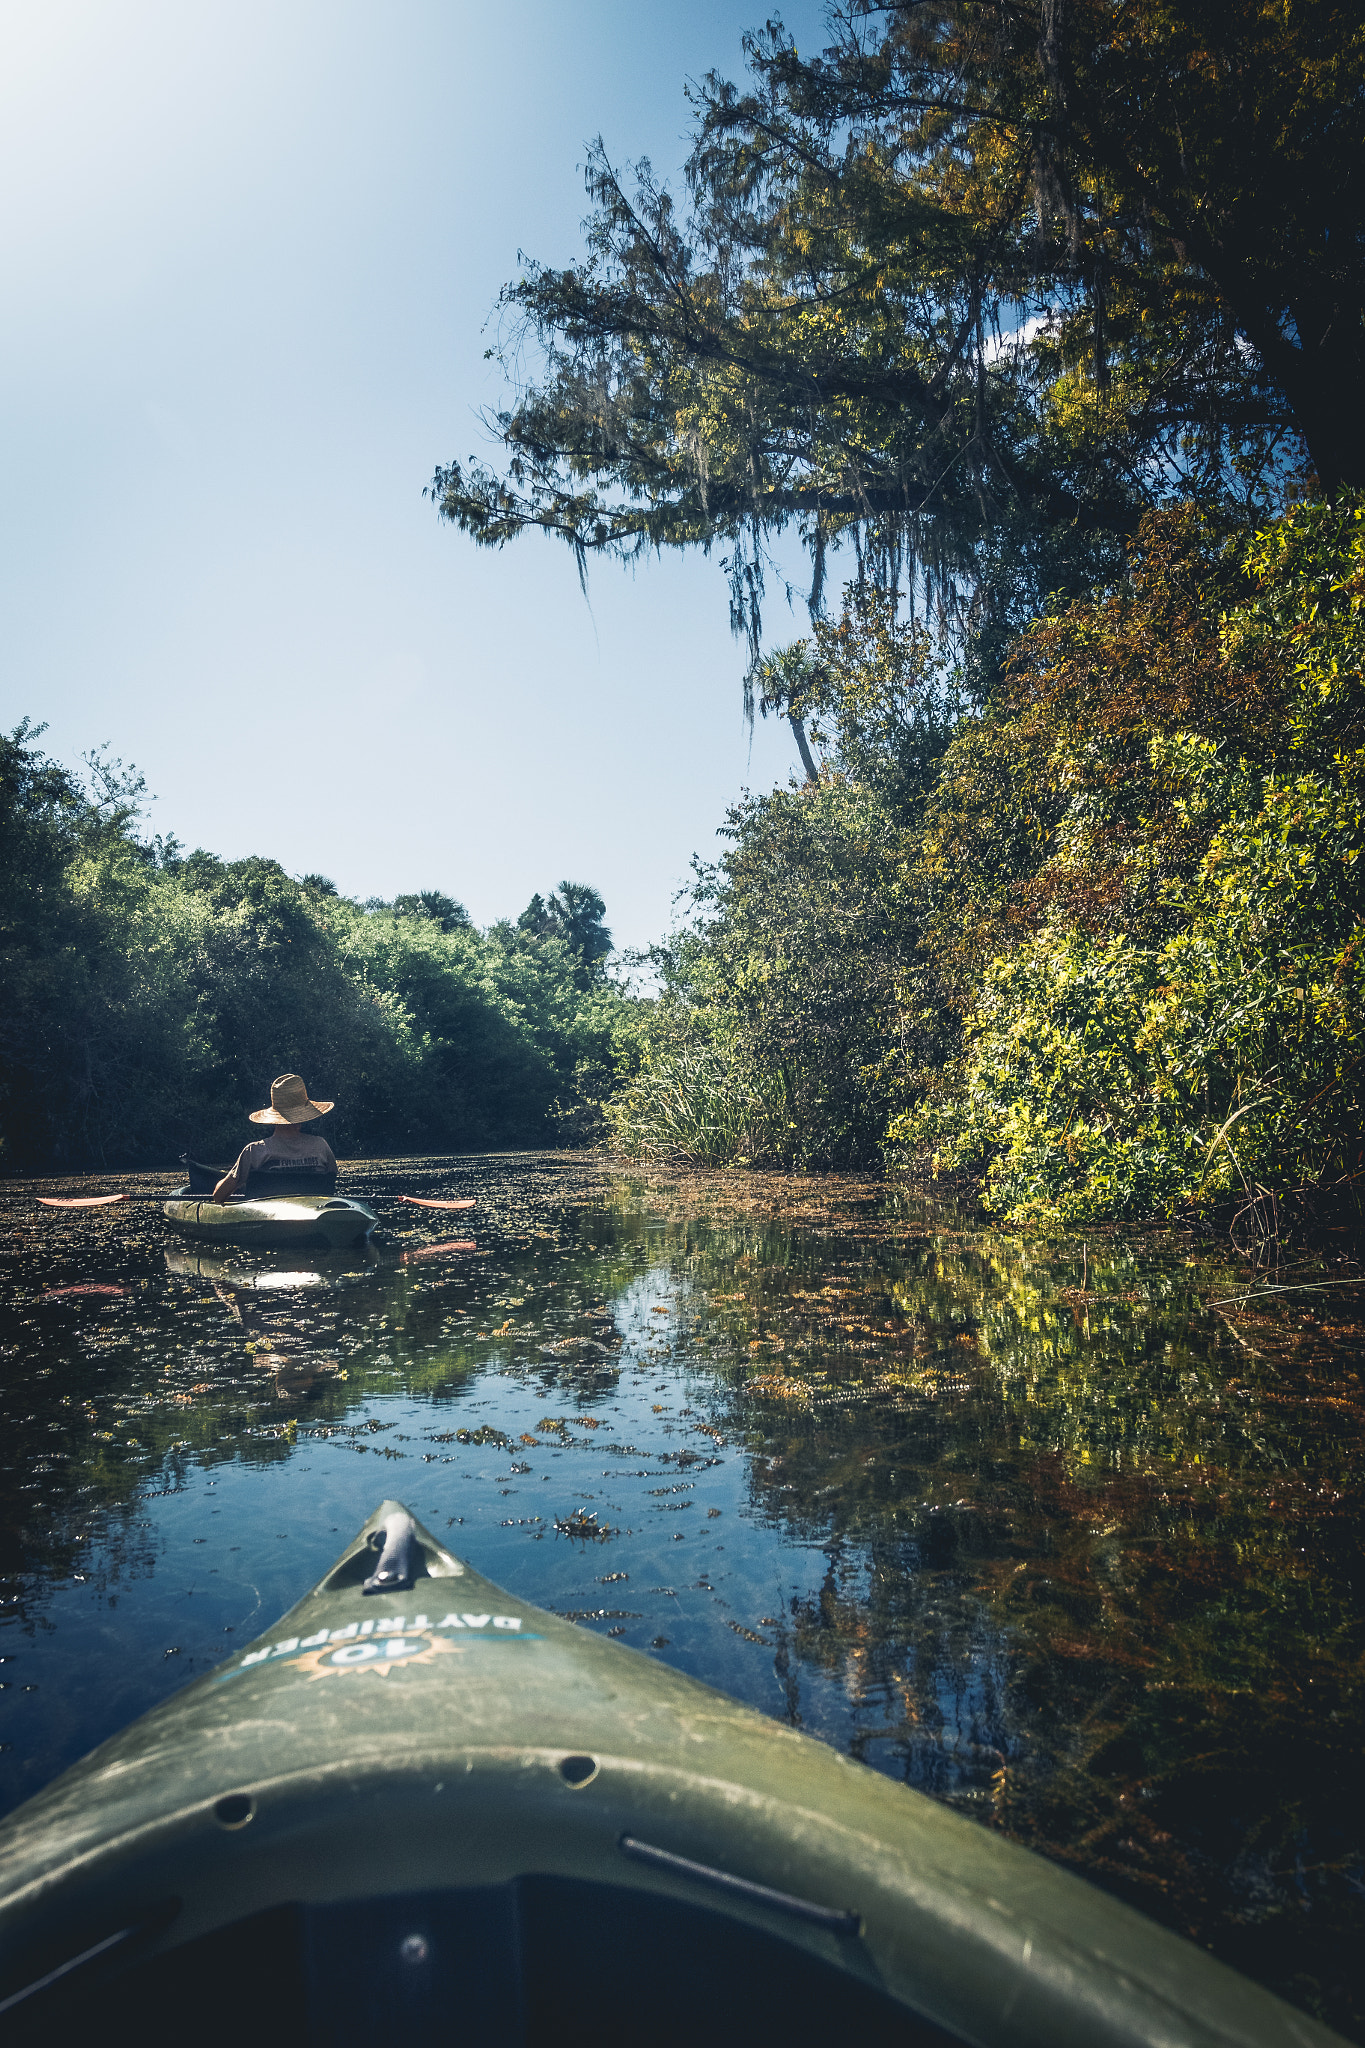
[608,768,941,1167]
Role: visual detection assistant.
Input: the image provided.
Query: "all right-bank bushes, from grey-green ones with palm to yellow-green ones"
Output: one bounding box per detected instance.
[610,496,1365,1223]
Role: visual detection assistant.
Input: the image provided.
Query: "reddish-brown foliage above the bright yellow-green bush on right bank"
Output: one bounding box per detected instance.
[921,508,1291,1008]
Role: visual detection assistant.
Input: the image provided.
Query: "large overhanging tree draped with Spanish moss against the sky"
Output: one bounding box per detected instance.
[432,0,1365,684]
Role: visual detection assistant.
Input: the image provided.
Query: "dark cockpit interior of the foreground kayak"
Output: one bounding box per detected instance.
[10,1876,960,2048]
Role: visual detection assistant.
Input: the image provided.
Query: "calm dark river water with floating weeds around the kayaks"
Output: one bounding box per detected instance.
[0,1155,1365,2036]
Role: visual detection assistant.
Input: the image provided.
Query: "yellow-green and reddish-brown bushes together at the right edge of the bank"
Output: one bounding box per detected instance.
[892,491,1365,1223]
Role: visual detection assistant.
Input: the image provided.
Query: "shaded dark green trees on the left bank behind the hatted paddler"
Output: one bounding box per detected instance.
[0,723,622,1174]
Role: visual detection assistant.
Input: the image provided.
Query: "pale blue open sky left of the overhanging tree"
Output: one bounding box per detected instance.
[0,0,821,944]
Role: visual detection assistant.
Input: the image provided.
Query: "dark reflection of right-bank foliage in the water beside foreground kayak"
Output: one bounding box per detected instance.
[675,1187,1365,2023]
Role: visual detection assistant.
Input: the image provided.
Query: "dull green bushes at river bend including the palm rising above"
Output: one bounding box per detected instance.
[608,590,952,1169]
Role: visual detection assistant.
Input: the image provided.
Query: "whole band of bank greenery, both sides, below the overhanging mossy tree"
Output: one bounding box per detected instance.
[0,494,1365,1223]
